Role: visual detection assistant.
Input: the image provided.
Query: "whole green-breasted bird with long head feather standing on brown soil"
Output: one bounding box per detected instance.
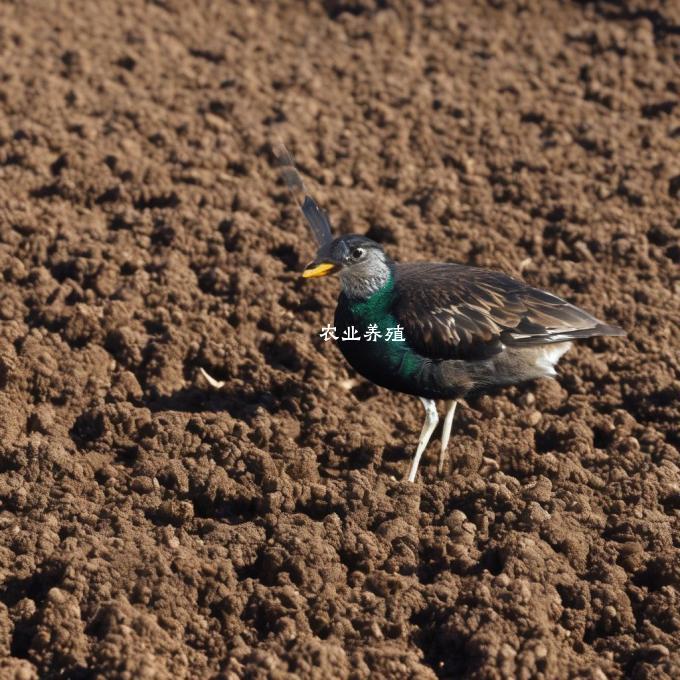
[273,143,626,482]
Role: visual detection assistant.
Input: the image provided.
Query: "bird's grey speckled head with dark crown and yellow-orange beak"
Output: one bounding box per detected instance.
[302,234,391,298]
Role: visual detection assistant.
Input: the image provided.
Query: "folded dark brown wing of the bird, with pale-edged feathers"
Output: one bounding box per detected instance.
[393,263,625,359]
